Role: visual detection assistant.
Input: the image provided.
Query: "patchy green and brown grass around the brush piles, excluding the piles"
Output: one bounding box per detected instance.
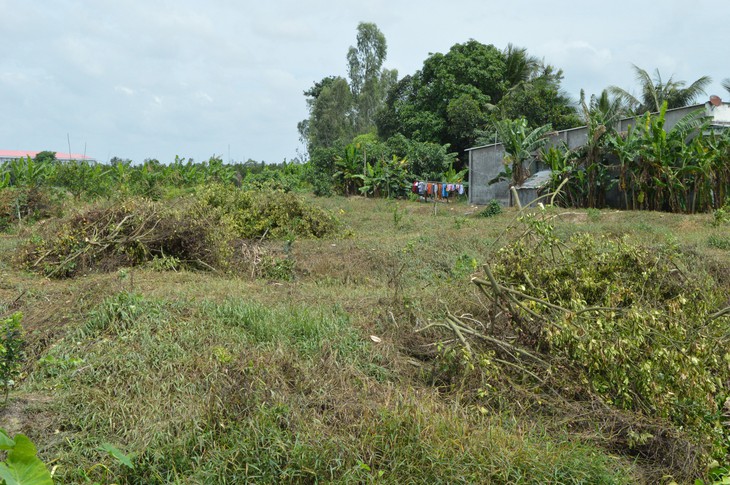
[0,198,730,483]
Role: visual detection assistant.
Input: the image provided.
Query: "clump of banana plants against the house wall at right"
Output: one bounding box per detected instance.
[541,100,730,213]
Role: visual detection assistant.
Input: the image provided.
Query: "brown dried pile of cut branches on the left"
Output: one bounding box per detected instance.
[21,199,235,278]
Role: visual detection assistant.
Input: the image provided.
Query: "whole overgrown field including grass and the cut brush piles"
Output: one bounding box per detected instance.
[0,193,730,484]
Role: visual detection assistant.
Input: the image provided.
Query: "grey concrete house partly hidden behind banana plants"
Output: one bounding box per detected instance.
[467,96,730,205]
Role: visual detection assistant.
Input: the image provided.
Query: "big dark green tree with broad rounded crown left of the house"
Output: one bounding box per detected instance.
[377,40,579,163]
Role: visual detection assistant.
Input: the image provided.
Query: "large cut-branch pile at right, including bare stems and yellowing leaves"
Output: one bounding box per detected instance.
[419,205,730,478]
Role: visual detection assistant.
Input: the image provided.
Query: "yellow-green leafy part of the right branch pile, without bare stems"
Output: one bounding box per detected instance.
[484,223,730,455]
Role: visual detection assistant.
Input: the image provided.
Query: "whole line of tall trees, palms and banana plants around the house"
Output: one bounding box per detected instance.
[298,22,730,211]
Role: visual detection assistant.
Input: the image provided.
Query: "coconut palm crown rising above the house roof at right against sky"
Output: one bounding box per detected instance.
[608,65,712,114]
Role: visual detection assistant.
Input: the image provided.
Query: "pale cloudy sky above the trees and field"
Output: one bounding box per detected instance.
[0,0,730,162]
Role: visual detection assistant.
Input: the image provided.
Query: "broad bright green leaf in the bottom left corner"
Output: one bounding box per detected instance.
[0,428,53,485]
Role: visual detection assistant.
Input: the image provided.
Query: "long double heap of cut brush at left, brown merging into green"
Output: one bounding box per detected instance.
[20,185,339,279]
